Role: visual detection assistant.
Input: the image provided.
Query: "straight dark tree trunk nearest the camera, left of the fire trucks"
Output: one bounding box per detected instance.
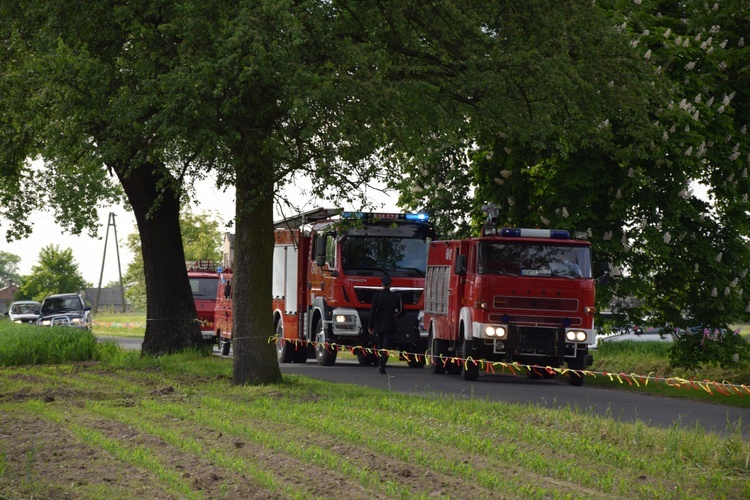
[232,162,281,385]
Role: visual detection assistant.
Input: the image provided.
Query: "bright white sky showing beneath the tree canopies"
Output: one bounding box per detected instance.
[0,179,397,287]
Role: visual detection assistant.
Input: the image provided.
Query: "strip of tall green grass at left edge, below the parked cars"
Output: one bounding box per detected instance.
[0,321,100,366]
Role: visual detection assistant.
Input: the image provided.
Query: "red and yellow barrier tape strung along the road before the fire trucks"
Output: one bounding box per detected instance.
[268,336,750,397]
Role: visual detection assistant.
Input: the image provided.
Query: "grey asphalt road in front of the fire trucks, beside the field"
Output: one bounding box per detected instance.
[106,337,750,439]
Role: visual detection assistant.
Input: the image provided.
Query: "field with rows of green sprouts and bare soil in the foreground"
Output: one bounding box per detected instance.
[0,352,750,498]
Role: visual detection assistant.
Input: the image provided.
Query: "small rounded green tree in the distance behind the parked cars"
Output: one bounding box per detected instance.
[18,245,89,302]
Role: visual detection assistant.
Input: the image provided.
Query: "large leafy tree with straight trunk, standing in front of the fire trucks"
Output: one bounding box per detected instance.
[156,0,672,383]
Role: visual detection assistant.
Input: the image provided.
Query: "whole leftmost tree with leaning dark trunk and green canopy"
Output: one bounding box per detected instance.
[0,0,201,354]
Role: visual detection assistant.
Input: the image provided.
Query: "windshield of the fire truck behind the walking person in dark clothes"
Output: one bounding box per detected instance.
[341,236,427,276]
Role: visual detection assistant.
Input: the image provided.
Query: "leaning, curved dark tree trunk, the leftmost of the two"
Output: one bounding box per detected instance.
[116,164,204,356]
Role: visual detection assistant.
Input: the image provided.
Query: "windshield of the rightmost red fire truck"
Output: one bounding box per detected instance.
[477,242,591,278]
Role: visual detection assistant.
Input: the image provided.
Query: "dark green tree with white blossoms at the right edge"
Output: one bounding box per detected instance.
[399,0,750,326]
